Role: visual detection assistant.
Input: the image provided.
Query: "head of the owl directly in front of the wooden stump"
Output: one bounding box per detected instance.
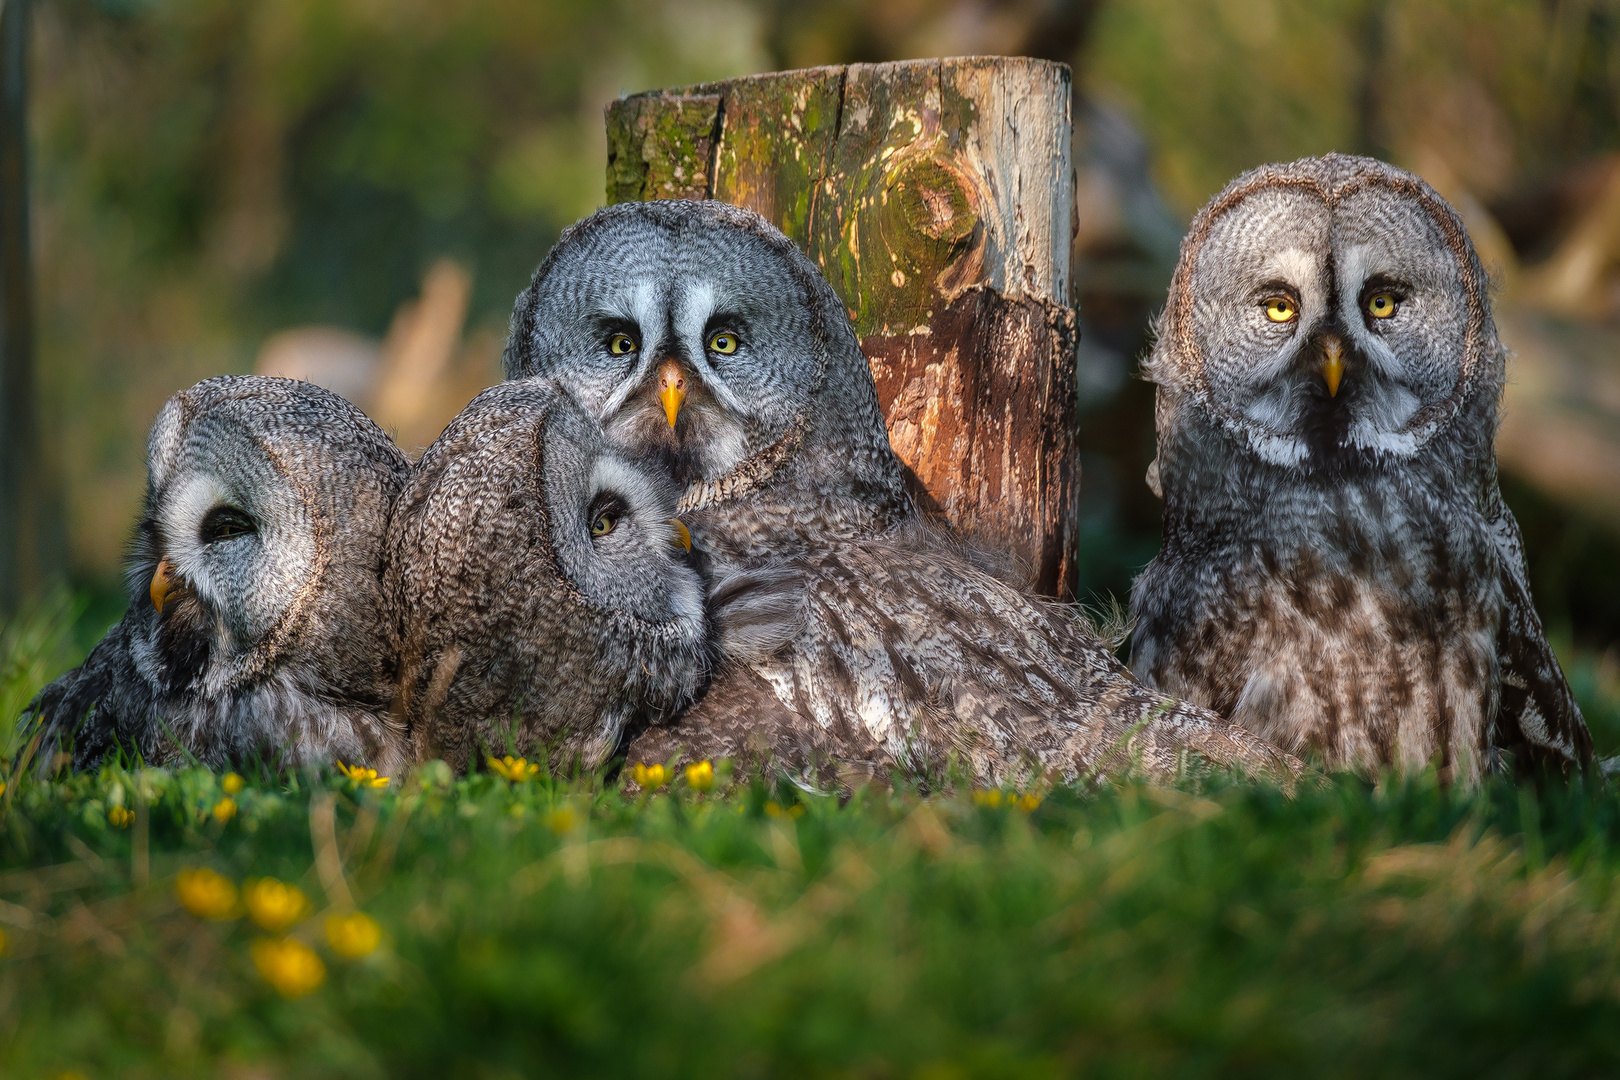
[505,201,909,557]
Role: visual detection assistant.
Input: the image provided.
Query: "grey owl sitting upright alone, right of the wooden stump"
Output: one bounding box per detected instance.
[1131,154,1591,784]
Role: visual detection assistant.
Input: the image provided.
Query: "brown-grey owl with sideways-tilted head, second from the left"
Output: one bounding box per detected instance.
[386,379,713,767]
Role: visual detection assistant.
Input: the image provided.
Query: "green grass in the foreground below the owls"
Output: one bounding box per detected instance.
[9,605,1620,1078]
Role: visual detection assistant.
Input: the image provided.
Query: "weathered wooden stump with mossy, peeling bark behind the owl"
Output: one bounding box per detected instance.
[608,57,1079,596]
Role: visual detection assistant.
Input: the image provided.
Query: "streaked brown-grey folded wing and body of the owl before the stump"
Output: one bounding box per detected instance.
[630,525,1299,787]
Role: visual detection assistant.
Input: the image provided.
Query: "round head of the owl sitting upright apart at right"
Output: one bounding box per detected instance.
[1147,154,1503,470]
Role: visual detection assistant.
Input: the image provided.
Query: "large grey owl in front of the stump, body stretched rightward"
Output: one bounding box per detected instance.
[505,202,1278,782]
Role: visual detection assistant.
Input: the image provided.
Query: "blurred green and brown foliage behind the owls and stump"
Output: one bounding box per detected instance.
[19,0,1620,687]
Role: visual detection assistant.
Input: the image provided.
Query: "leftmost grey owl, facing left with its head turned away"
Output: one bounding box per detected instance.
[29,376,410,776]
